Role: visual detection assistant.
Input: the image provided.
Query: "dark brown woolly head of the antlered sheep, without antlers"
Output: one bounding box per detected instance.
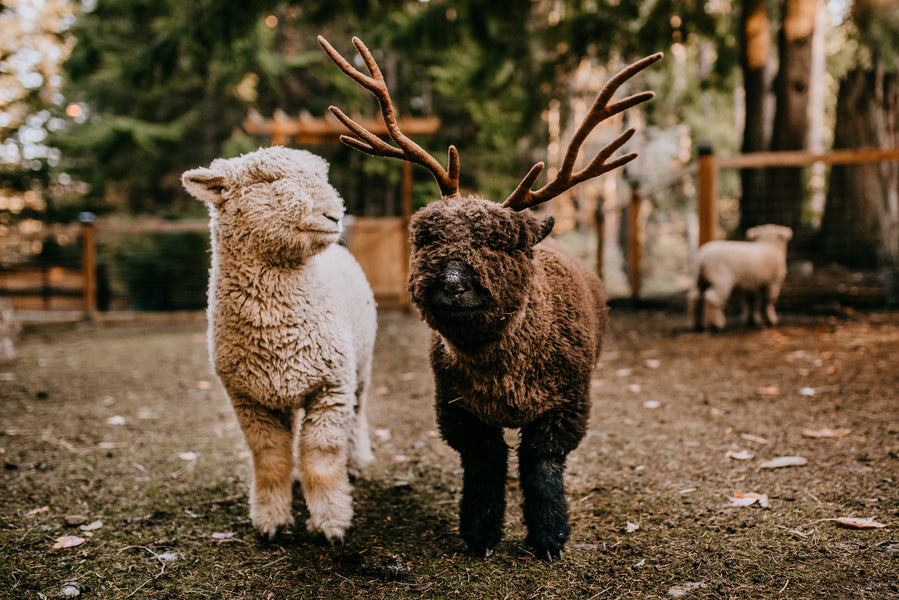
[409,196,552,349]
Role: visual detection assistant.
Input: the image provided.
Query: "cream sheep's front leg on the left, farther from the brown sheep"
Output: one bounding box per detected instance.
[234,400,293,538]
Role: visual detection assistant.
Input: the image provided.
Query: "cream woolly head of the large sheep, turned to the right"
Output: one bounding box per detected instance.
[182,147,344,266]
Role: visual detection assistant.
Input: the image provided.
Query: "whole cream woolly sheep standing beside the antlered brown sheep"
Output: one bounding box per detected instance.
[182,147,376,542]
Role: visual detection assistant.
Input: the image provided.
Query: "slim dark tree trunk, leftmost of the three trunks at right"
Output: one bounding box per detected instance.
[740,0,771,231]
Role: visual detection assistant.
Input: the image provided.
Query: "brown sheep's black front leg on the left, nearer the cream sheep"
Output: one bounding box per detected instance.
[437,403,509,557]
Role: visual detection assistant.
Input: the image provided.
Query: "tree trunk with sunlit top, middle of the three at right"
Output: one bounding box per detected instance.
[760,0,818,230]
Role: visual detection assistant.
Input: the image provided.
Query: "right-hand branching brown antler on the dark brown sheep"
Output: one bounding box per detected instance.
[503,52,662,210]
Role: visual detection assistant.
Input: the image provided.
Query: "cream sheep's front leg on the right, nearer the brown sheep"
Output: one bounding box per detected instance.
[299,398,353,543]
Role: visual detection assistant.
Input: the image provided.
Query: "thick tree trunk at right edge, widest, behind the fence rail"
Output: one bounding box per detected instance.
[820,60,899,267]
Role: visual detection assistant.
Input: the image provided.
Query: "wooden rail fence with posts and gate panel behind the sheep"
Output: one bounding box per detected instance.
[7,149,899,318]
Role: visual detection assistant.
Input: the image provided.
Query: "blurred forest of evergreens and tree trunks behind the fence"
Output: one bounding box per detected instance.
[0,0,899,308]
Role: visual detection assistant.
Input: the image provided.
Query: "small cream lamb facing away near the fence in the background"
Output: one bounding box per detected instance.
[687,224,793,330]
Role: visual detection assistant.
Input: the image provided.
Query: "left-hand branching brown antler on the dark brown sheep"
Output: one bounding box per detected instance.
[318,36,459,197]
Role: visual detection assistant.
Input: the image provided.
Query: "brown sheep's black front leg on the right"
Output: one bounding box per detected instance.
[518,409,587,562]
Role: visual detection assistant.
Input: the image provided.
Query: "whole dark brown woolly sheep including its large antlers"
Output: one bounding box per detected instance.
[319,37,661,561]
